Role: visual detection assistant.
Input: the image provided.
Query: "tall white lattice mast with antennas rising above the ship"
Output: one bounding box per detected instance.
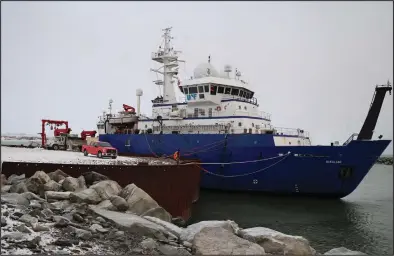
[151,27,180,103]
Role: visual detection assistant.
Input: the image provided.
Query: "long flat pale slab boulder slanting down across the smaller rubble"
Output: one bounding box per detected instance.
[90,206,176,240]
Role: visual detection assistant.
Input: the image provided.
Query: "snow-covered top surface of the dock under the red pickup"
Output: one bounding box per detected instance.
[1,147,172,165]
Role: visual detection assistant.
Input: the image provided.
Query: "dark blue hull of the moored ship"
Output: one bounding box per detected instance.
[99,134,391,198]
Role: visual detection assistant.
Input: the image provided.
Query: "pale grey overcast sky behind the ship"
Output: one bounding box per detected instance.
[1,2,393,153]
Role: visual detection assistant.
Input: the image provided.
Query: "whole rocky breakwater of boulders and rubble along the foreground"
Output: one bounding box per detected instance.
[1,170,368,255]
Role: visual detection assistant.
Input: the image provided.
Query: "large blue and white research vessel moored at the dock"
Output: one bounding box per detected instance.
[97,28,392,198]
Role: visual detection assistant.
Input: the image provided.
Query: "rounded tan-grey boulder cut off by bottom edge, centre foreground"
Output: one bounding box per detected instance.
[193,227,265,255]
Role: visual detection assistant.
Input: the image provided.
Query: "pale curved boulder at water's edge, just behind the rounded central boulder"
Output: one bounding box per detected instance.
[180,220,239,243]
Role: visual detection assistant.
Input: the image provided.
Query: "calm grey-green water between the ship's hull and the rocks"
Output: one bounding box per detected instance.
[192,165,393,255]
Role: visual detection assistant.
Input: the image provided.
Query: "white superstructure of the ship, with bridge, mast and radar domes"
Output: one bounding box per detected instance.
[97,28,311,146]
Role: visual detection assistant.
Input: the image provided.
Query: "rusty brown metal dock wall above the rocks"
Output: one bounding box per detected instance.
[1,162,200,220]
